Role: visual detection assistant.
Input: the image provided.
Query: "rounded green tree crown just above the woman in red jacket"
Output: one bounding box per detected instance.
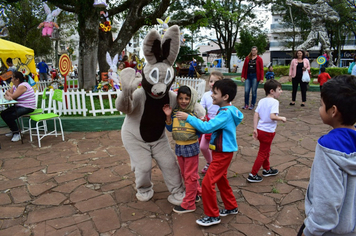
[235,27,268,59]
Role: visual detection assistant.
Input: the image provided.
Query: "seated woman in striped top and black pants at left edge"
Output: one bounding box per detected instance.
[1,71,36,142]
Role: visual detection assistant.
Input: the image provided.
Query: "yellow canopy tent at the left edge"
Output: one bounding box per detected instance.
[0,39,38,81]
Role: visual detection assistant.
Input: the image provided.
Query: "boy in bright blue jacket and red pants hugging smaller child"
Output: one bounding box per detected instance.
[176,79,243,226]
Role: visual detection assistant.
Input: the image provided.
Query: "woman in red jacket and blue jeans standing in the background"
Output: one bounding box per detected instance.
[241,46,264,110]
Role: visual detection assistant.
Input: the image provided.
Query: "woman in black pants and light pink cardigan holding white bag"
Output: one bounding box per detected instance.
[289,50,310,107]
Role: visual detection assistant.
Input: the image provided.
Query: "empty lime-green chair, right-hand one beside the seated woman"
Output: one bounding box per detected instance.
[28,89,64,147]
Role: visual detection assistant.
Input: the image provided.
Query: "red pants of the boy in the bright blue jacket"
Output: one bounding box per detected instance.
[202,151,237,217]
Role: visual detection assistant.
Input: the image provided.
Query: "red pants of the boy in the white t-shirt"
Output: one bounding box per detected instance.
[251,129,276,175]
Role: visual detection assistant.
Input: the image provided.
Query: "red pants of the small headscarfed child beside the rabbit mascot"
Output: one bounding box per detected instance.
[177,155,201,210]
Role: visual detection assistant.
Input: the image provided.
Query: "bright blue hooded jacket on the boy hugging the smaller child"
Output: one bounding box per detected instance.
[187,105,244,152]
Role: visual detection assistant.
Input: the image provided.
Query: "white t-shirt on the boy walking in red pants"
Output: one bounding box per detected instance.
[255,97,279,133]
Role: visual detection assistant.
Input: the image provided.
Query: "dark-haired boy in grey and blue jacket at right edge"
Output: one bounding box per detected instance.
[298,75,356,236]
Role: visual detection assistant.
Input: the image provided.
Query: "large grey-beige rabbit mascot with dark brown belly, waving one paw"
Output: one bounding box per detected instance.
[115,25,205,205]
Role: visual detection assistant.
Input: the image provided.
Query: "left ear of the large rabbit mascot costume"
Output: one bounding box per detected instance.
[143,29,163,65]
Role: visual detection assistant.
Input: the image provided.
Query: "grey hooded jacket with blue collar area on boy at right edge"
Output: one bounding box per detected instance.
[304,128,356,236]
